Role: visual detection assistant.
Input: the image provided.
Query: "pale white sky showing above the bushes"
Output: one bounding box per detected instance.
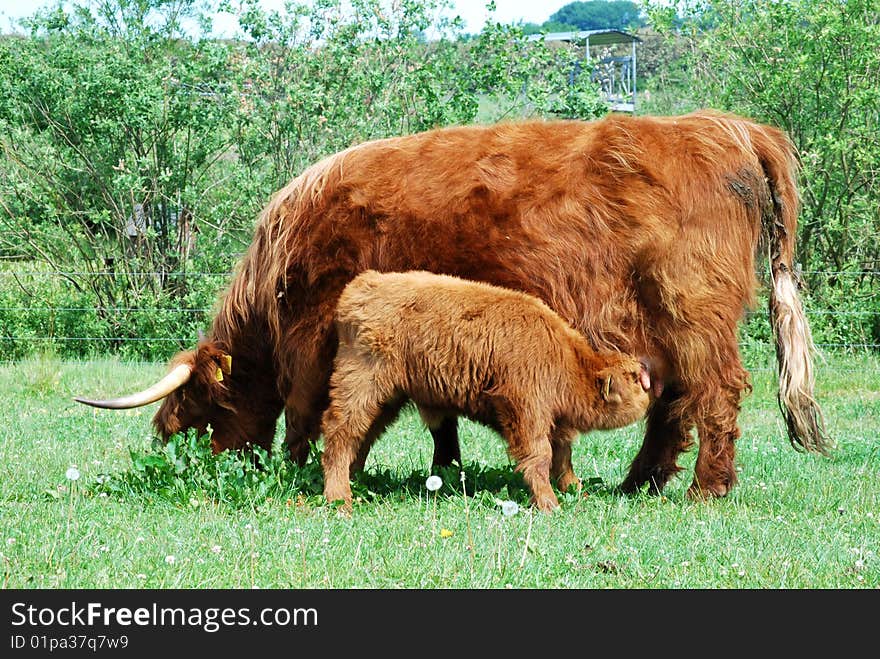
[0,0,571,32]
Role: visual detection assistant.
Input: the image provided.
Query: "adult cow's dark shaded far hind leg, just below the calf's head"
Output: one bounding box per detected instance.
[620,386,693,494]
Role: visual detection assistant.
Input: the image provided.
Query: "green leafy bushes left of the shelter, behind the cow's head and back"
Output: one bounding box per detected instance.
[0,0,605,359]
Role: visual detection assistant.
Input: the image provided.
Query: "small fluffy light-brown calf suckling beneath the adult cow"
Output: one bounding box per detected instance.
[322,270,650,511]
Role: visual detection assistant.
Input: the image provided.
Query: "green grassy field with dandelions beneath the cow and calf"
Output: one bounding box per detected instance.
[0,356,880,588]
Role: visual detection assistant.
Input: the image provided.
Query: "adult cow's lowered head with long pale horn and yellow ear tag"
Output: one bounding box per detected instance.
[75,340,262,453]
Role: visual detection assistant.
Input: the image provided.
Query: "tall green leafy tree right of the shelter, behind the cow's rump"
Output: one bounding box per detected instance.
[653,0,880,343]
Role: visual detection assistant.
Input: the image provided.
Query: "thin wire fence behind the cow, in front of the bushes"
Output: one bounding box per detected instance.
[0,270,880,371]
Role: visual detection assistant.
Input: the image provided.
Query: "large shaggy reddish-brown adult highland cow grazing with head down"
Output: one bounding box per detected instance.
[77,112,831,496]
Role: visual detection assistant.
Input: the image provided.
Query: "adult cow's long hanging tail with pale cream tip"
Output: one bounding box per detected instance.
[751,126,833,455]
